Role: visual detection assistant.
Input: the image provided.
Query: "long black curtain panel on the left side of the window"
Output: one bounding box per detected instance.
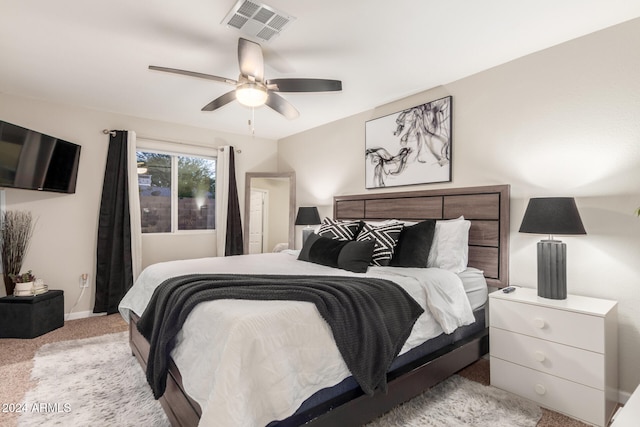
[93,131,133,314]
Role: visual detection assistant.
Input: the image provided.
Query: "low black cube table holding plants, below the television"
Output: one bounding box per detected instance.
[0,290,64,338]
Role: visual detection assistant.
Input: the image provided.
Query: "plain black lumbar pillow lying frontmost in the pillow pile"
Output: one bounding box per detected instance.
[298,233,374,273]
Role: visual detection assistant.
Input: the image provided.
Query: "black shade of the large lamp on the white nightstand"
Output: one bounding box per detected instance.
[520,197,587,234]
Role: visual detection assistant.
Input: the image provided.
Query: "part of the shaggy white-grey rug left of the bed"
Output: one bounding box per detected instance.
[18,332,170,427]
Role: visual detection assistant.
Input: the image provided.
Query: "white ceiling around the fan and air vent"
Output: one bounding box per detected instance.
[0,0,640,139]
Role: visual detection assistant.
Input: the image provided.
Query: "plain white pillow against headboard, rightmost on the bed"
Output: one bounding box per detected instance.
[427,216,471,273]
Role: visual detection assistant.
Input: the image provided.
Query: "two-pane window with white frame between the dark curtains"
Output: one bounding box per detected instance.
[136,151,216,233]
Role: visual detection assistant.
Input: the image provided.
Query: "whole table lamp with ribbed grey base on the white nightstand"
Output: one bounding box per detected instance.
[519,197,587,299]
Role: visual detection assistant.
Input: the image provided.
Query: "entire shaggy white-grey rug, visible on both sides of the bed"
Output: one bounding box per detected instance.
[18,332,542,427]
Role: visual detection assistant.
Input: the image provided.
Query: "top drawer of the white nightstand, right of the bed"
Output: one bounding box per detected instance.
[489,298,605,353]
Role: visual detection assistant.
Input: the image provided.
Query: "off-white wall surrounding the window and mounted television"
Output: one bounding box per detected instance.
[0,93,277,313]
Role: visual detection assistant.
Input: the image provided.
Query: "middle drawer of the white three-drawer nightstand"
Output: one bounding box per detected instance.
[489,328,605,390]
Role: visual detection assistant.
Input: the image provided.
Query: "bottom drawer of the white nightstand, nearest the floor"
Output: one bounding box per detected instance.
[491,358,606,426]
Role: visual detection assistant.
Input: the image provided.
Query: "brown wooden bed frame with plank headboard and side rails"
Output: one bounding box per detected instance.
[129,185,509,427]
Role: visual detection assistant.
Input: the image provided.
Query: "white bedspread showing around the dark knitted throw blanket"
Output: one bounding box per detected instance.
[119,251,474,427]
